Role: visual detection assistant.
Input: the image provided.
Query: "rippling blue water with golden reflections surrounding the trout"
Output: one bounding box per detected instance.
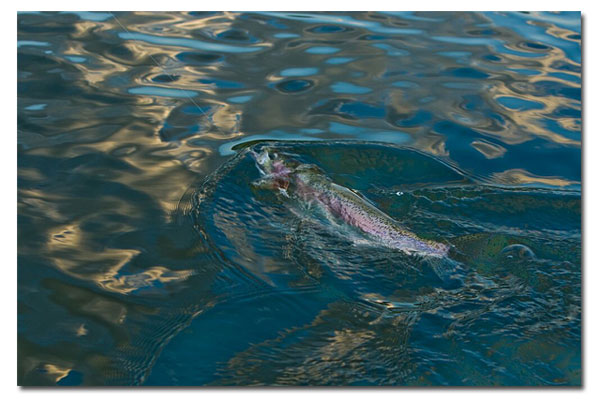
[17,12,581,385]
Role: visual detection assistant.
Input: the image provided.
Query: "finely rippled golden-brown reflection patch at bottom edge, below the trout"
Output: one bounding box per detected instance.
[218,303,410,385]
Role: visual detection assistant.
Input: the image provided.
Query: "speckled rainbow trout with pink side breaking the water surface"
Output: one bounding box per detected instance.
[250,147,450,258]
